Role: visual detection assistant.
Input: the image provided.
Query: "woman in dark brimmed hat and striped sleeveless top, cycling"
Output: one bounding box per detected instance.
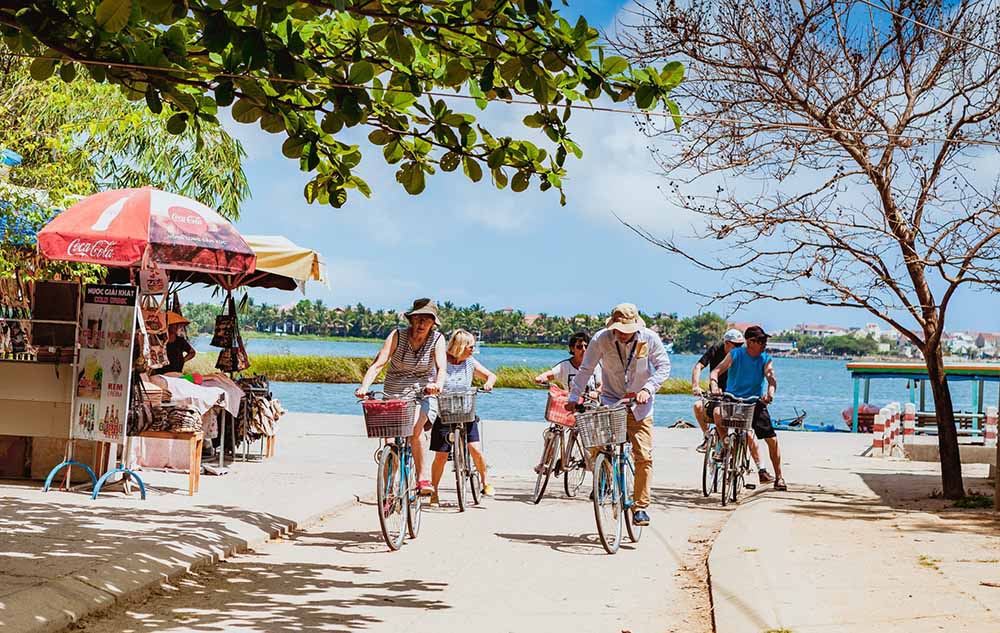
[354,298,447,496]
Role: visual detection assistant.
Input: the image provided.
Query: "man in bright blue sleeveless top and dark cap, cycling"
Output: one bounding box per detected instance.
[709,325,788,490]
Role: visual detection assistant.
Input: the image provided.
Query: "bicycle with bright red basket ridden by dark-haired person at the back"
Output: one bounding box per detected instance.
[531,385,587,505]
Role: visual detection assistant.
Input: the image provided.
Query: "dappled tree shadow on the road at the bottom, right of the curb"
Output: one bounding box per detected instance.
[77,557,450,633]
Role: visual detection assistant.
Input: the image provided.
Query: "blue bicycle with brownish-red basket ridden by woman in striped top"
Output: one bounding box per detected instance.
[361,392,423,551]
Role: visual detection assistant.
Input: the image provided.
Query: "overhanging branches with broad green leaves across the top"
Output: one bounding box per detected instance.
[0,0,684,207]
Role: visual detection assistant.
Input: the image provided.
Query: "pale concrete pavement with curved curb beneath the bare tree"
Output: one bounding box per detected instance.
[709,433,1000,633]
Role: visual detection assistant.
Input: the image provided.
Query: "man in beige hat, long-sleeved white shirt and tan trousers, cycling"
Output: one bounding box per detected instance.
[566,303,670,525]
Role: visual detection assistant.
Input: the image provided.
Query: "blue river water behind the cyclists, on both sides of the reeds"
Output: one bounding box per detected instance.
[193,337,997,429]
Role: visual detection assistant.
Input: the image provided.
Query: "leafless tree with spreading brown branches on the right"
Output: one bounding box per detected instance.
[616,0,1000,498]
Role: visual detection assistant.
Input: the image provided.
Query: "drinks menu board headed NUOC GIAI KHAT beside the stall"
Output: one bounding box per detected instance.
[73,285,138,444]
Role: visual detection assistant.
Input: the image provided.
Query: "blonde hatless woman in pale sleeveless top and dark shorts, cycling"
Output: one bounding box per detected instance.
[431,329,497,505]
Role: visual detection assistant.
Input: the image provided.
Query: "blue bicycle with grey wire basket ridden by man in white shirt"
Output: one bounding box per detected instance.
[576,398,642,554]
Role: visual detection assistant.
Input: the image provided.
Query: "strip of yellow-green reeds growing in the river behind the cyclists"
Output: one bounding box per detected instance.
[184,353,708,394]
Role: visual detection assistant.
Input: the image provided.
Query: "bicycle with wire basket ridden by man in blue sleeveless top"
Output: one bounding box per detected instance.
[702,393,759,506]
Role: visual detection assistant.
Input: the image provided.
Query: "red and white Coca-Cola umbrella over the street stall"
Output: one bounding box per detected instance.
[38,187,257,274]
